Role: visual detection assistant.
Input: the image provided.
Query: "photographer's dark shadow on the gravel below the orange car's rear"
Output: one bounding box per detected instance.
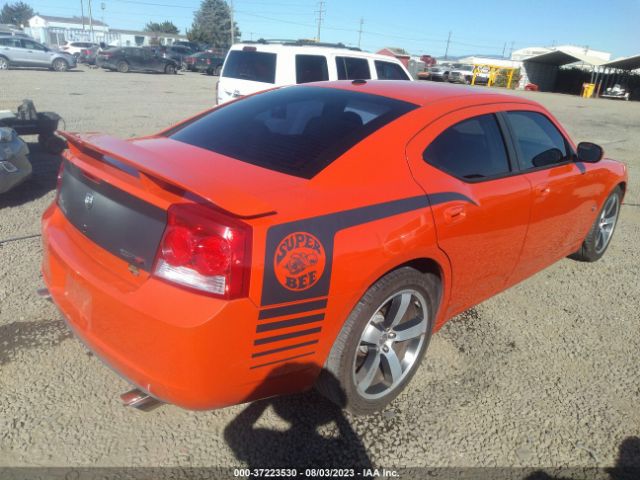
[224,363,372,471]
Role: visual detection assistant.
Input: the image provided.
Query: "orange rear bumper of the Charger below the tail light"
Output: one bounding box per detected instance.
[42,205,309,410]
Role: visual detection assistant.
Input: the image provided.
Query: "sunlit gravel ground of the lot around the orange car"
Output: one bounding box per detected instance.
[0,69,640,467]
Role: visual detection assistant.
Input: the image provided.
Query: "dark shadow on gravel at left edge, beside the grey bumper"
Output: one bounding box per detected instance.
[0,143,62,209]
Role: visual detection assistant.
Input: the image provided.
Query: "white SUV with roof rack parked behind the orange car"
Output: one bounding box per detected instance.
[216,41,412,104]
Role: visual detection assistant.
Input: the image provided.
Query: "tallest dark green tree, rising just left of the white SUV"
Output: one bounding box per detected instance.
[187,0,240,48]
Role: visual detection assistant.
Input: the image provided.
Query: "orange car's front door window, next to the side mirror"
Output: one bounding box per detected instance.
[507,111,568,170]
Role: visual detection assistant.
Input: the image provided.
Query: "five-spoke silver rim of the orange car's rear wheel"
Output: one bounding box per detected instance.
[353,289,429,399]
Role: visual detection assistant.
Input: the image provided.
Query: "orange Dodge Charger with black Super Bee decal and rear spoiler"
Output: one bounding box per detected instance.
[42,80,627,414]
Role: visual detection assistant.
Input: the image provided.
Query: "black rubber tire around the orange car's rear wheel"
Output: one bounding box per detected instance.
[316,267,440,415]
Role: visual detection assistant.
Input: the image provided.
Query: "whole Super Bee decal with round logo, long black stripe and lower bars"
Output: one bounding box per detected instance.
[250,192,476,369]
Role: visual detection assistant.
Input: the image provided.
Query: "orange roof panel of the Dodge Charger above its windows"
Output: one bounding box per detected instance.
[305,80,537,106]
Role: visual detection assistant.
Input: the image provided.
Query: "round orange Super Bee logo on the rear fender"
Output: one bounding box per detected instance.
[273,232,326,292]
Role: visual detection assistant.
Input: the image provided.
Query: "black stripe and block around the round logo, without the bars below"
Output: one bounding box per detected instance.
[260,192,477,306]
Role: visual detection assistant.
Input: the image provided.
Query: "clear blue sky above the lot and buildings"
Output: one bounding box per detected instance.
[11,0,640,58]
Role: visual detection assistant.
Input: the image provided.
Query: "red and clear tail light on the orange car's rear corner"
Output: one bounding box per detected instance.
[153,204,251,299]
